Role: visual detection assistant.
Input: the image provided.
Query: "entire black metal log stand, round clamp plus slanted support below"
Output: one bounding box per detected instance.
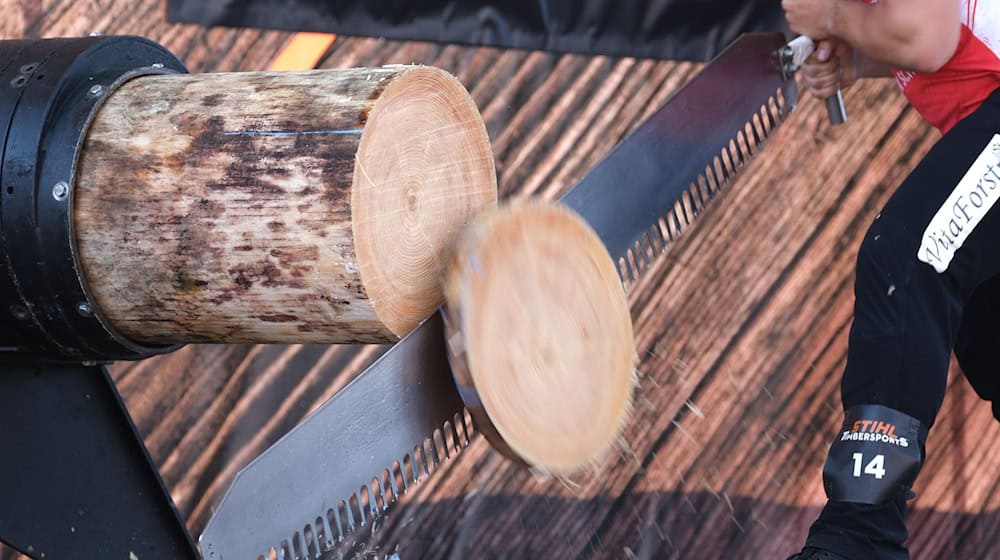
[0,36,198,560]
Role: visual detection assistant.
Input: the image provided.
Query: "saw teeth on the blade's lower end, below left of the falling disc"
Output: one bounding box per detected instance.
[257,410,476,560]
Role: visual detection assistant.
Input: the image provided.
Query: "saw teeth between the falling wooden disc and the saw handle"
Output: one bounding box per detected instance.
[618,89,787,290]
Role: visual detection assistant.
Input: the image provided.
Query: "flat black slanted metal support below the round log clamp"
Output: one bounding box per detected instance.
[0,360,199,560]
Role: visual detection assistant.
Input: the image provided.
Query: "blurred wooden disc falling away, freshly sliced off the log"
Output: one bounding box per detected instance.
[445,202,635,476]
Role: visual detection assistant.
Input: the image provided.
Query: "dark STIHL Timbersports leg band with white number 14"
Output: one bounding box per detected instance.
[823,405,927,505]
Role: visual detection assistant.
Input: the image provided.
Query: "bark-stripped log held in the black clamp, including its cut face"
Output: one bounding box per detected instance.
[73,65,497,344]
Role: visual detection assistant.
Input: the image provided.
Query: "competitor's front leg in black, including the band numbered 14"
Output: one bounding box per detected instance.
[806,85,1000,559]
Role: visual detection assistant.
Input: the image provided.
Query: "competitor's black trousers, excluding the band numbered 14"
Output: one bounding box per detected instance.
[806,91,1000,560]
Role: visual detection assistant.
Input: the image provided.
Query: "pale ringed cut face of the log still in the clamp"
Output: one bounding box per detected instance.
[351,67,497,336]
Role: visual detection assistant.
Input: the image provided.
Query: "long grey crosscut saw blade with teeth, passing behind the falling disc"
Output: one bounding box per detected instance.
[200,33,797,560]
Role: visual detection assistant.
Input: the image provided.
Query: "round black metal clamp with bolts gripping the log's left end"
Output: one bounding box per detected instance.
[0,36,187,362]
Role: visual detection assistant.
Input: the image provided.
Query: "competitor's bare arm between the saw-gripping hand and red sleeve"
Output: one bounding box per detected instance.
[830,0,961,72]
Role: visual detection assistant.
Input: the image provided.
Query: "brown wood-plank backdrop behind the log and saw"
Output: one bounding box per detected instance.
[0,0,1000,560]
